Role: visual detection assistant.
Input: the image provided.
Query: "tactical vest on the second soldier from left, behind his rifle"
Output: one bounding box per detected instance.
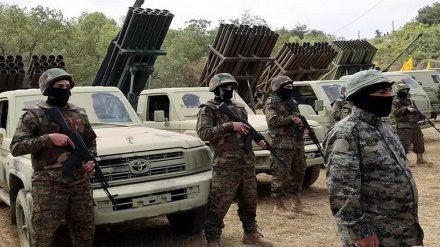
[200,100,247,153]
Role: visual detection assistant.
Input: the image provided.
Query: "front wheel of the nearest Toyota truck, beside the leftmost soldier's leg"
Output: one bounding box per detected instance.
[15,189,32,247]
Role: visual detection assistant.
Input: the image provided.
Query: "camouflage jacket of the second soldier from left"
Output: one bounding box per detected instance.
[196,99,255,165]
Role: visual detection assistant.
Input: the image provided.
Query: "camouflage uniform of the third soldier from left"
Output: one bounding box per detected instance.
[263,94,307,197]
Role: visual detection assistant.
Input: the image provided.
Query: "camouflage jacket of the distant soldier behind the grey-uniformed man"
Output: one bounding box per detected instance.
[392,97,420,128]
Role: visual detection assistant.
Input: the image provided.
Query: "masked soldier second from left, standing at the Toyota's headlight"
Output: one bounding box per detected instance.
[197,73,273,247]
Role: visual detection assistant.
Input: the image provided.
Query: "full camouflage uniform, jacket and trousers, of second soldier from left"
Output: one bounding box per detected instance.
[197,100,257,242]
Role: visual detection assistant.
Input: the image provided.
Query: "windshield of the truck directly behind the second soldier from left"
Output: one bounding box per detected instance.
[175,91,254,119]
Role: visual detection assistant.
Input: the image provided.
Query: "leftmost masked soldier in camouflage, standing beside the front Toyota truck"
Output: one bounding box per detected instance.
[10,68,96,247]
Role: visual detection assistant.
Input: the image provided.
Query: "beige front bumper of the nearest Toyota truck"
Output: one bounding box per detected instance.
[93,170,212,225]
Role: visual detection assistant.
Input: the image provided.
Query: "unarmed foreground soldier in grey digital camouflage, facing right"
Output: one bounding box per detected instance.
[323,70,423,247]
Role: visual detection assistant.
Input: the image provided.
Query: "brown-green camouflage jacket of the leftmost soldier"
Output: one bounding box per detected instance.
[10,101,96,173]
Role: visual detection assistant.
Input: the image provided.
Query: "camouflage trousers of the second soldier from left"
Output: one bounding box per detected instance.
[205,159,257,242]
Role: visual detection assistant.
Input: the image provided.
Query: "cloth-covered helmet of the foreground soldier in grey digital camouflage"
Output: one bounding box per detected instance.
[345,69,393,100]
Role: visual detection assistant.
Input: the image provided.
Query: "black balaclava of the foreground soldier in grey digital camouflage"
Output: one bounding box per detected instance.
[350,82,393,117]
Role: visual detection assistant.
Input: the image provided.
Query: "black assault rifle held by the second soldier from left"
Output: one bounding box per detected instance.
[217,102,288,166]
